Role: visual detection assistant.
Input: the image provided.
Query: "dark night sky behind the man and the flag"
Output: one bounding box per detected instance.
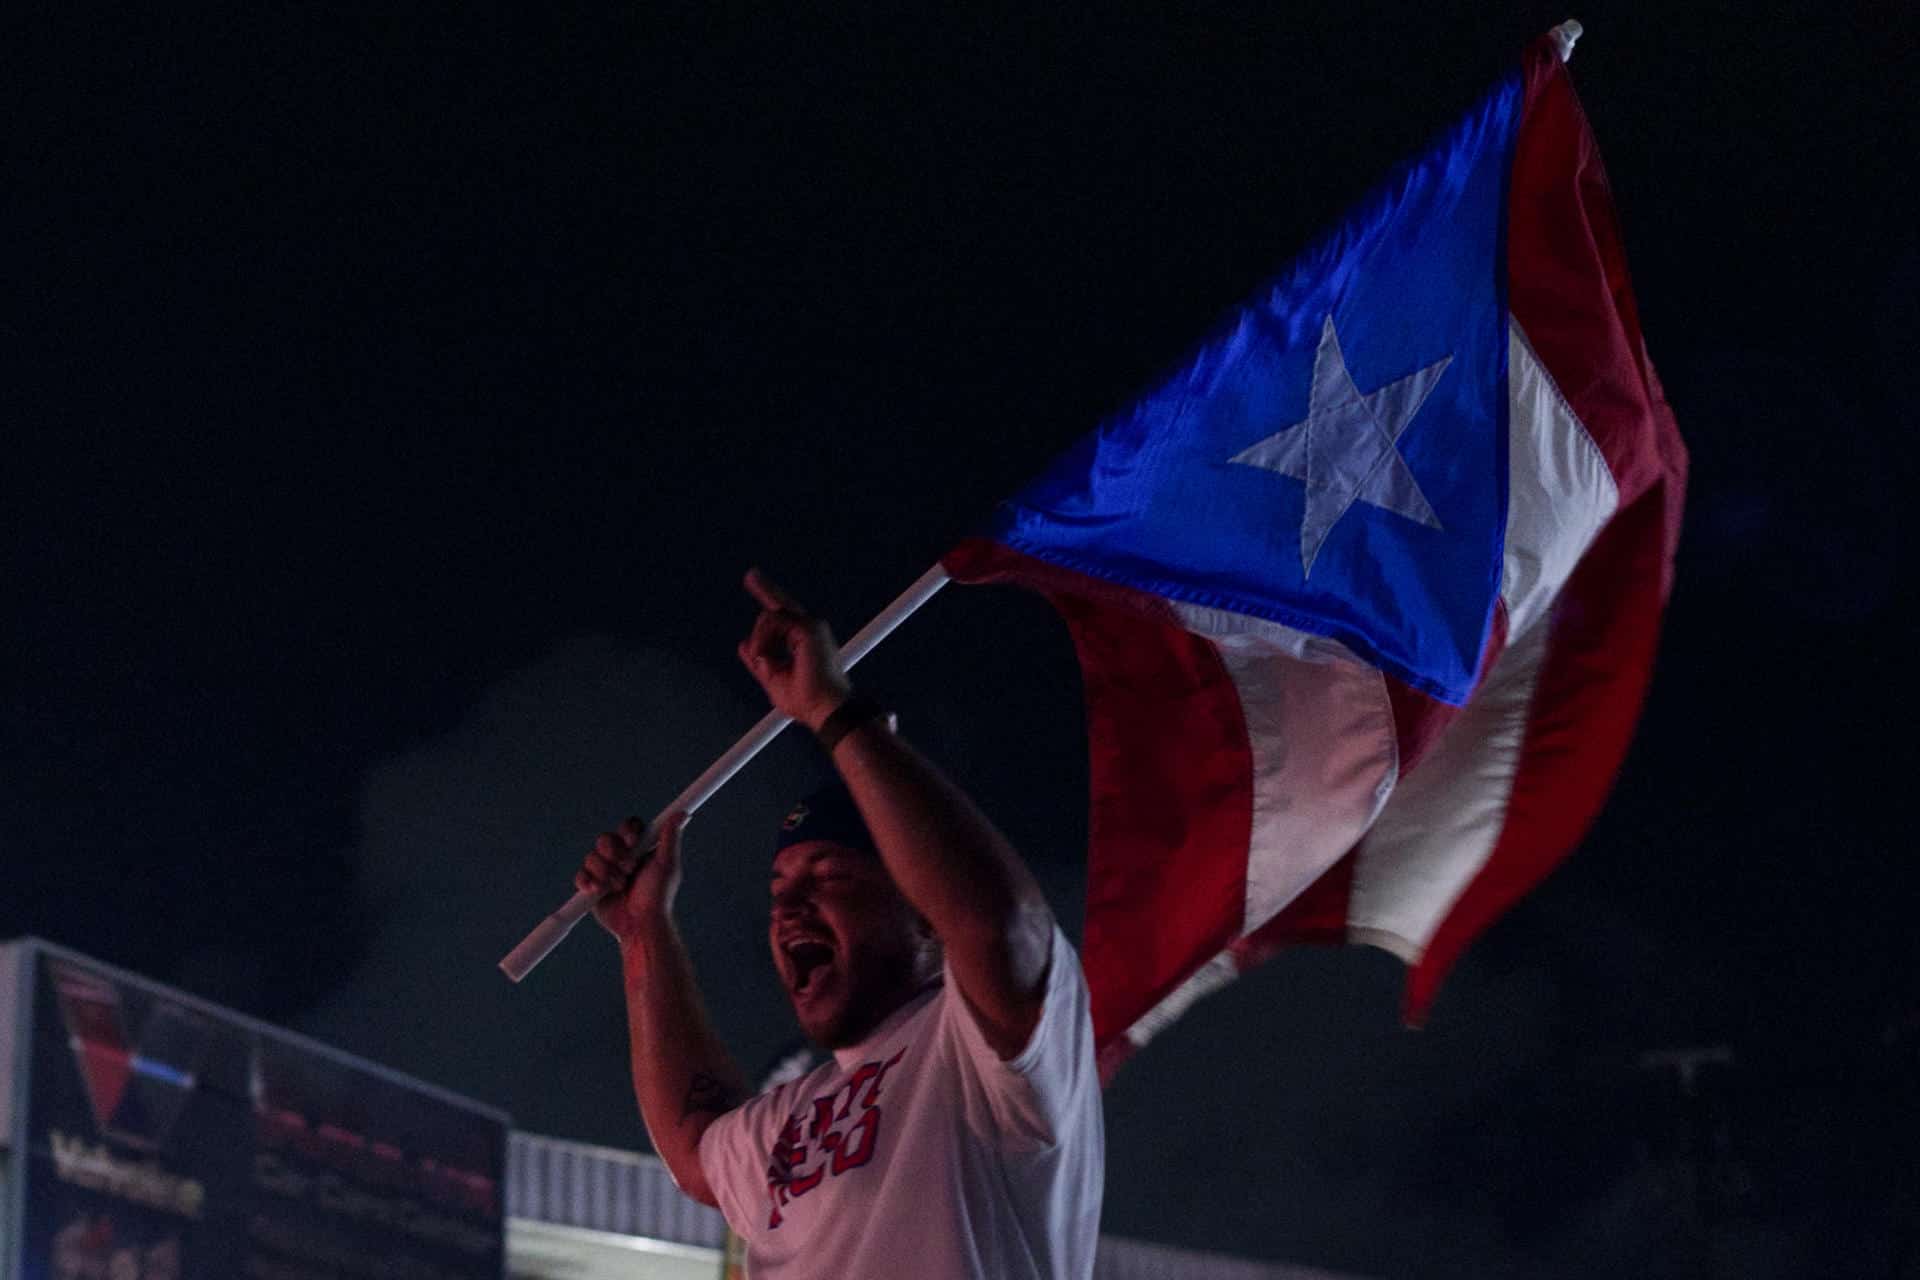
[0,0,1920,1276]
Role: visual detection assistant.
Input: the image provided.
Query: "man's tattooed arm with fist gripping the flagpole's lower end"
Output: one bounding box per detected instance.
[574,816,747,1205]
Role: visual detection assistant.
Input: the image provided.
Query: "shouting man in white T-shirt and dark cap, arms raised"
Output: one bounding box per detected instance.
[574,572,1106,1280]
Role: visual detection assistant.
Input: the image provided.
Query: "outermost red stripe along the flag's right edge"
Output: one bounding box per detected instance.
[1405,42,1686,1023]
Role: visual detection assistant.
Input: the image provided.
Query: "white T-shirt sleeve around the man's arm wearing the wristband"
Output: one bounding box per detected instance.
[943,923,1100,1151]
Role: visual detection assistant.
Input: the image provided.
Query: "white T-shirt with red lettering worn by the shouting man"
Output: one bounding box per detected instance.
[701,927,1106,1280]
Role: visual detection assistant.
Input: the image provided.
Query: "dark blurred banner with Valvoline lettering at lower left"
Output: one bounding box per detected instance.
[0,942,507,1280]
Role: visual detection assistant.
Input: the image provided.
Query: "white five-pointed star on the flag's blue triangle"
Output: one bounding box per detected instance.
[1229,315,1453,576]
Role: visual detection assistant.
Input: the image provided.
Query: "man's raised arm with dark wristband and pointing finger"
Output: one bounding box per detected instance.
[739,572,1054,1057]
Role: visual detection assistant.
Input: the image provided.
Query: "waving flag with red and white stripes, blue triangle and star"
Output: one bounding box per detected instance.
[945,25,1686,1071]
